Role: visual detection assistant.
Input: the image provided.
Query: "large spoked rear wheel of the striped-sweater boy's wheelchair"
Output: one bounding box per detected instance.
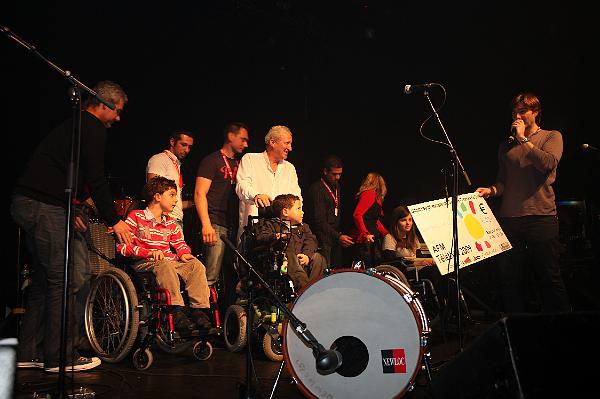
[85,268,139,363]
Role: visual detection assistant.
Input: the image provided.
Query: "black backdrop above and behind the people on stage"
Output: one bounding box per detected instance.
[0,0,600,304]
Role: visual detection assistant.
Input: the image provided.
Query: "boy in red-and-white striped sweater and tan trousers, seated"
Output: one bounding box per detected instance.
[117,176,211,334]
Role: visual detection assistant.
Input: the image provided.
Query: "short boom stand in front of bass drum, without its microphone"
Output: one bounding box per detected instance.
[220,234,341,399]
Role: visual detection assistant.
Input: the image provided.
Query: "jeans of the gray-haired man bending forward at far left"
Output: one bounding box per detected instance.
[10,194,89,367]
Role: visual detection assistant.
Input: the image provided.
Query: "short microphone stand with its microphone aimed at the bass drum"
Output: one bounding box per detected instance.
[220,234,342,399]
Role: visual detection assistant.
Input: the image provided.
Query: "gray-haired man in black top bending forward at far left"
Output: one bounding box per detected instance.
[11,81,131,372]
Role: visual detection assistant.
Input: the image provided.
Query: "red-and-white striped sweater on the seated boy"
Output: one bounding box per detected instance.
[117,208,192,260]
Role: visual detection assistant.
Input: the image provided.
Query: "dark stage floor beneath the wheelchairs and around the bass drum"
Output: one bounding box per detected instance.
[15,320,493,399]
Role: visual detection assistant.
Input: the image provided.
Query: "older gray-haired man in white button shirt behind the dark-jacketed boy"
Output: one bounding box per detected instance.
[235,125,302,240]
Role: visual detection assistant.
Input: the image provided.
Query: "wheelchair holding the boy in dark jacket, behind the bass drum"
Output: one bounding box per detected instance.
[223,213,296,362]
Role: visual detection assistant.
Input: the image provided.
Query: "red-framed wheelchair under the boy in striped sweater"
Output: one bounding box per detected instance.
[85,255,221,370]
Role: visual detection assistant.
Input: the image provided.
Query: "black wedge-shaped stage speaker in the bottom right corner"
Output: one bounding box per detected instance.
[431,312,600,399]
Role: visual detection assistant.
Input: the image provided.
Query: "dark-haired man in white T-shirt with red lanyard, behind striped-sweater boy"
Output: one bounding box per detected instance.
[146,130,194,232]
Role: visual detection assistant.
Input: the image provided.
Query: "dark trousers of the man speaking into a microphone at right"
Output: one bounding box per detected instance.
[498,216,571,313]
